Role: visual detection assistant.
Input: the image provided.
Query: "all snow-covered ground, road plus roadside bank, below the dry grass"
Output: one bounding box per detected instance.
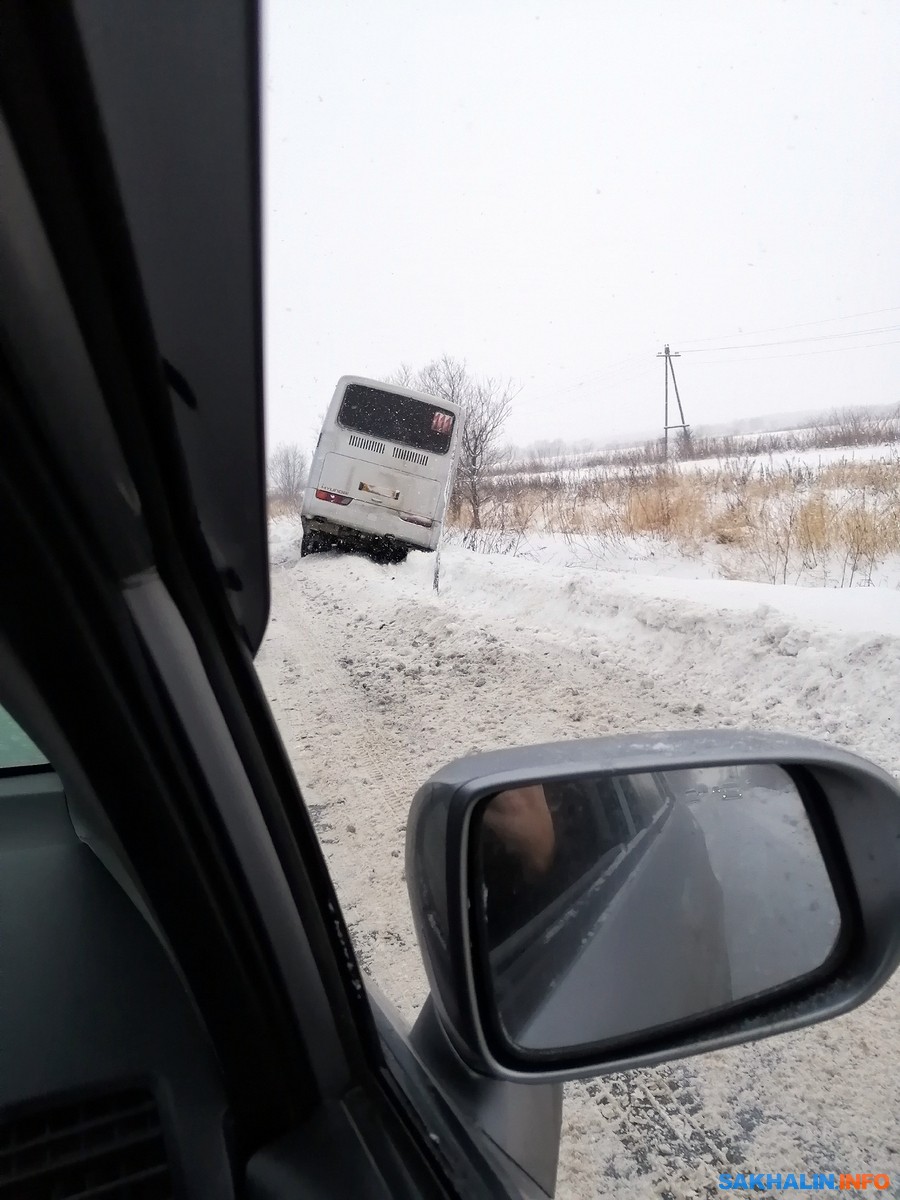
[258,521,900,1200]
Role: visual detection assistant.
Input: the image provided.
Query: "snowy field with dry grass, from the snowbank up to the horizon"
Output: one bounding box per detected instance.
[480,442,900,588]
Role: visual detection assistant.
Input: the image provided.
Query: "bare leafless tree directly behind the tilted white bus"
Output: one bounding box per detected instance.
[386,354,518,529]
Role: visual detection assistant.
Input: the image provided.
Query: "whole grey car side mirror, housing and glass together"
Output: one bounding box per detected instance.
[407,732,900,1080]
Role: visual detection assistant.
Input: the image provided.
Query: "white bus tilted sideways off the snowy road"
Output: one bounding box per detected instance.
[300,376,464,562]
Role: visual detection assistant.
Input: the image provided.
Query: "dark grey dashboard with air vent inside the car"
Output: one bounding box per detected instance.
[0,769,234,1200]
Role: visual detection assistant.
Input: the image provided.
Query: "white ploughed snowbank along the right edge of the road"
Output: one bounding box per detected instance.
[274,530,900,773]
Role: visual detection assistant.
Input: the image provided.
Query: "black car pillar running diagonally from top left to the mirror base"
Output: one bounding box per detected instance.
[0,0,571,1195]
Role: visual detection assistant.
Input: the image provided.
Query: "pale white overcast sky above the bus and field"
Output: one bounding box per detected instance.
[264,0,900,446]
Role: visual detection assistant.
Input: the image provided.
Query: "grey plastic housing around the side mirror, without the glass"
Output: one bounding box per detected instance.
[407,731,900,1082]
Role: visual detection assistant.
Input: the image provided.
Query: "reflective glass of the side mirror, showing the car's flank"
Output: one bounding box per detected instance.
[470,764,840,1051]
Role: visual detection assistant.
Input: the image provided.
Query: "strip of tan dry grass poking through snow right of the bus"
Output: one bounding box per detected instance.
[456,451,900,587]
